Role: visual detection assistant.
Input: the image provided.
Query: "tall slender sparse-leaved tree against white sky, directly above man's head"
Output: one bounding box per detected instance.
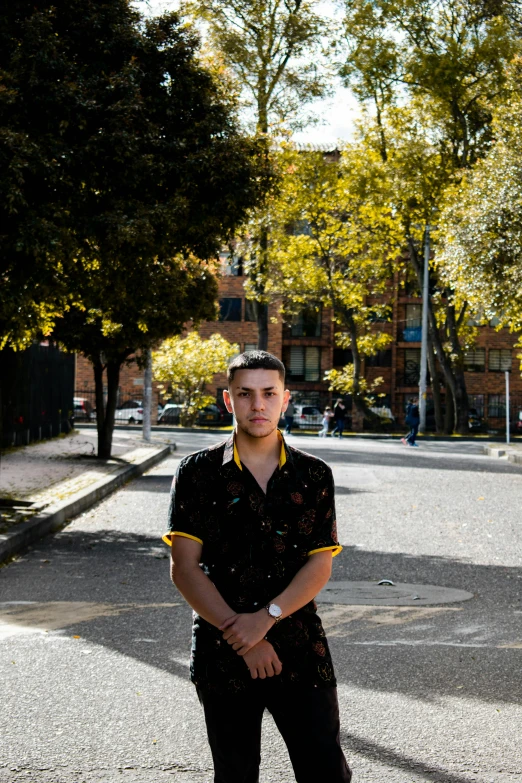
[187,0,327,350]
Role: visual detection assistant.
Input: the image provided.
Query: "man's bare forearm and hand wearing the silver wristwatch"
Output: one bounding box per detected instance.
[219,551,332,655]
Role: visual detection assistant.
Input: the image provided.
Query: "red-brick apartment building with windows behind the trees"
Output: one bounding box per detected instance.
[76,254,522,429]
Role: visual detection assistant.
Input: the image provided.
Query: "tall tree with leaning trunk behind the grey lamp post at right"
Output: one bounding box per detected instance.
[342,0,516,433]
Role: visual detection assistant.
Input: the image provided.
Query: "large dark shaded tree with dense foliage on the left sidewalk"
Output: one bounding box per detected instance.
[0,0,270,457]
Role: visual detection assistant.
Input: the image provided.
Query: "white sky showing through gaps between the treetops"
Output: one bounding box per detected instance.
[133,0,359,144]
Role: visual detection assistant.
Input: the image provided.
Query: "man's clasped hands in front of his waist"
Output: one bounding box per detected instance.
[219,609,282,680]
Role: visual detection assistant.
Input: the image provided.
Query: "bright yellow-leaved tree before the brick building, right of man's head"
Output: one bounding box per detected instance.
[268,144,399,417]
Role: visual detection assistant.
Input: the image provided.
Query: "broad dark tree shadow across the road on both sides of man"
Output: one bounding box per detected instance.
[0,528,522,712]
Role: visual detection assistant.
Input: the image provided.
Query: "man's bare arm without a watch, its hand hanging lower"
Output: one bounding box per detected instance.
[170,536,282,679]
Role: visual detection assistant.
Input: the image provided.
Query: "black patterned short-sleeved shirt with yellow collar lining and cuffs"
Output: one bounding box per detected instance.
[163,435,342,692]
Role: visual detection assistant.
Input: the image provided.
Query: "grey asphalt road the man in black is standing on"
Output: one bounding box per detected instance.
[0,433,522,783]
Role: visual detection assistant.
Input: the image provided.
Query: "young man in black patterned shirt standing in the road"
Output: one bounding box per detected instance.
[164,351,351,783]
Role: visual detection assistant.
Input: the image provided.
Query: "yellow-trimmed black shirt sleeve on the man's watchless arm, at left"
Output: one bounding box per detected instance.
[162,460,203,546]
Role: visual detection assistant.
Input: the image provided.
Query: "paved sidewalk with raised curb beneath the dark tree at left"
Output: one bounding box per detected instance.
[0,429,175,562]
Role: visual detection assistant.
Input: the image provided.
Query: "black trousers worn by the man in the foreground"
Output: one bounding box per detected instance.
[198,678,352,783]
